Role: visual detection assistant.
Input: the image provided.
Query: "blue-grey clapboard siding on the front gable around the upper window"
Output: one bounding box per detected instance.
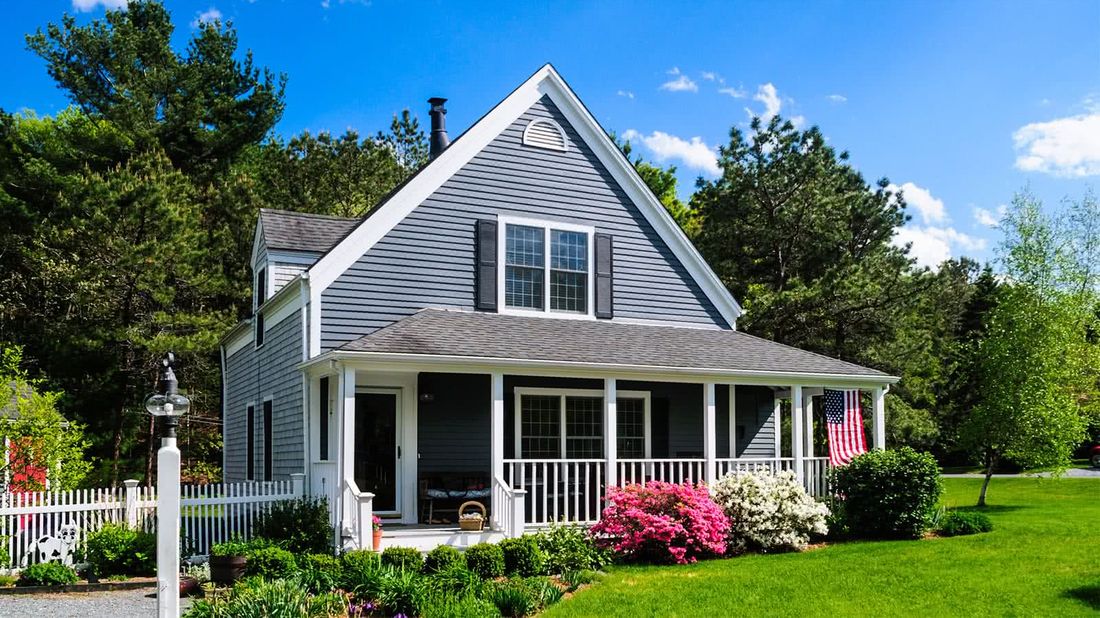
[321,98,728,350]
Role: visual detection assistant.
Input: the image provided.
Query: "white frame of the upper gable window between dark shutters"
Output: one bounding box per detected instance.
[496,216,596,320]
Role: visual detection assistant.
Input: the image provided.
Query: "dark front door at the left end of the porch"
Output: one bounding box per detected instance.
[355,389,402,514]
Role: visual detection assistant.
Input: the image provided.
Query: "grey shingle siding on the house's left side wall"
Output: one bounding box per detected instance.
[223,312,305,481]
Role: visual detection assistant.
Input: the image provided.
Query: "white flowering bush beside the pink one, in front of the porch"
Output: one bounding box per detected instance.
[711,471,829,551]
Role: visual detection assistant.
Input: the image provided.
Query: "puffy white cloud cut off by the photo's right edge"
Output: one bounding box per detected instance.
[1012,109,1100,178]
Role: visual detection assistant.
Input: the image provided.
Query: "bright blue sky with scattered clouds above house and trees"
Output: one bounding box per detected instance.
[0,0,1100,264]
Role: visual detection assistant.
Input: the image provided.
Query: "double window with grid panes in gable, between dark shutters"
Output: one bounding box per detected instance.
[497,218,593,316]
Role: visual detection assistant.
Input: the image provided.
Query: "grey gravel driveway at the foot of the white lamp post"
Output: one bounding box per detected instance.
[0,588,190,618]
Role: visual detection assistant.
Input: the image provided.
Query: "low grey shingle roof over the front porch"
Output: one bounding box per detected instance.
[339,309,888,379]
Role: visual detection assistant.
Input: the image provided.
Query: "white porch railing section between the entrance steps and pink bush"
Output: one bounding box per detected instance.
[503,460,604,526]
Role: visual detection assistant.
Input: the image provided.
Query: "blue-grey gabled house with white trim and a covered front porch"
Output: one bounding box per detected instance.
[222,65,897,547]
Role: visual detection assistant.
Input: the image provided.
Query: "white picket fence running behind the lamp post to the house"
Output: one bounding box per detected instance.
[0,474,305,567]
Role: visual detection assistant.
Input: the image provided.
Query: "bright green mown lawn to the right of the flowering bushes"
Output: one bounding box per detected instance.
[543,478,1100,618]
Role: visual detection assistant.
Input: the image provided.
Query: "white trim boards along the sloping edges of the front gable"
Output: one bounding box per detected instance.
[308,64,743,356]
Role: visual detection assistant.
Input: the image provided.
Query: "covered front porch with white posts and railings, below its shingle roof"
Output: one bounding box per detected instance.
[308,358,884,549]
